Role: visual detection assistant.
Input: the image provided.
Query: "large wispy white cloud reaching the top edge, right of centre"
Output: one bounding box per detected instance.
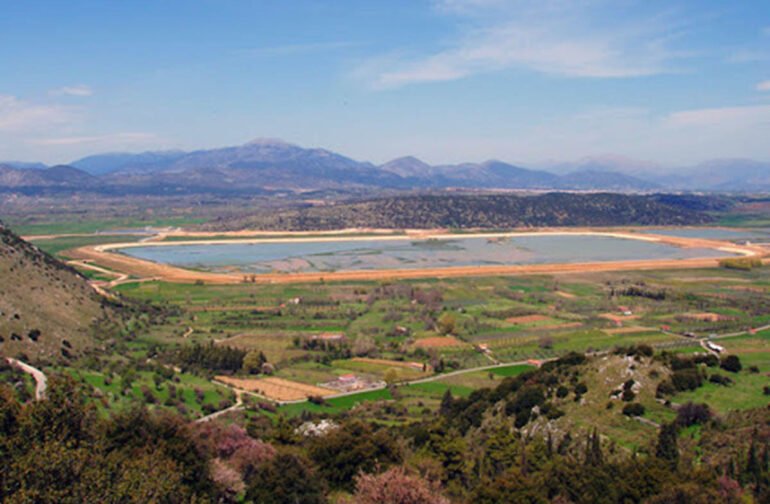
[359,0,683,88]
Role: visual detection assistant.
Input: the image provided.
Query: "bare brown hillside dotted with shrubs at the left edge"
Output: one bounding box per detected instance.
[0,223,113,360]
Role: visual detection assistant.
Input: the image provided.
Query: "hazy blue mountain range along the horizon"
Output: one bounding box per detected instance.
[0,139,770,194]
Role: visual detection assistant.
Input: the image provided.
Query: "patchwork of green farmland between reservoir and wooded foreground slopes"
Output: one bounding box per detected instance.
[40,228,770,422]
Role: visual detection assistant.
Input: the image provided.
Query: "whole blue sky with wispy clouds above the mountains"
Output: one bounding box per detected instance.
[0,0,770,167]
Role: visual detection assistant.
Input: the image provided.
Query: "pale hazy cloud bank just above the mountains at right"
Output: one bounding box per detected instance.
[408,102,770,165]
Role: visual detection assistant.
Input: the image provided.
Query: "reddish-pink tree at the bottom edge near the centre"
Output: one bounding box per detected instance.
[353,466,449,504]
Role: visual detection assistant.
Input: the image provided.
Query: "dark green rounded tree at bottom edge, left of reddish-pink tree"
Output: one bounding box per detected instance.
[246,453,326,504]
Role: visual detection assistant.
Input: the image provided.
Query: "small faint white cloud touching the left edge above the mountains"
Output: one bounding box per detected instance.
[0,95,76,132]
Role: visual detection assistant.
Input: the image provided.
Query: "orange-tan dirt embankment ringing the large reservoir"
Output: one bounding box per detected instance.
[68,229,768,284]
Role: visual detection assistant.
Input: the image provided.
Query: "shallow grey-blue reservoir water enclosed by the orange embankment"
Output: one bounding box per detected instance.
[116,234,730,273]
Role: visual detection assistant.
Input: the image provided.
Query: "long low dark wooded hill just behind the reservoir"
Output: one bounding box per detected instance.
[212,193,713,230]
